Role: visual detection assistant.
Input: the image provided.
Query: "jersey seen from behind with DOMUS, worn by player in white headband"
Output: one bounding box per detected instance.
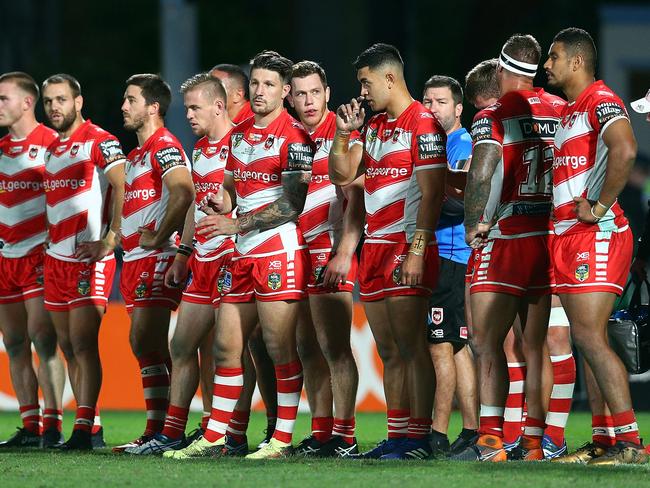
[471,90,559,239]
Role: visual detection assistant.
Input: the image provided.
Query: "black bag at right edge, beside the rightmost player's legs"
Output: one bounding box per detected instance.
[607,280,650,374]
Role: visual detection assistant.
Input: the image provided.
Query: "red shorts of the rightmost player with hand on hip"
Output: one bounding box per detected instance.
[553,228,633,295]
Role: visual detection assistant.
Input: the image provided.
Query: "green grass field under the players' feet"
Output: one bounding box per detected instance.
[0,411,650,488]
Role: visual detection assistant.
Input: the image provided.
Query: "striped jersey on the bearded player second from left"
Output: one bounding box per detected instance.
[44,120,124,262]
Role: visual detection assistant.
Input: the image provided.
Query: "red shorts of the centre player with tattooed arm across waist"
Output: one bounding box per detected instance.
[218,249,309,303]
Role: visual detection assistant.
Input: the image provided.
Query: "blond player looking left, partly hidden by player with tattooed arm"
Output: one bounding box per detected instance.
[126,73,233,455]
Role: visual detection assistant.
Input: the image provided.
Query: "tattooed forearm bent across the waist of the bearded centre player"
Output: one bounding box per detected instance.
[197,171,311,238]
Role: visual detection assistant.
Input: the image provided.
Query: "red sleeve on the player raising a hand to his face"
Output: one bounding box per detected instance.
[411,112,447,171]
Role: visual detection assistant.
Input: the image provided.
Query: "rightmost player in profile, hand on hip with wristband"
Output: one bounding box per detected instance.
[544,28,648,465]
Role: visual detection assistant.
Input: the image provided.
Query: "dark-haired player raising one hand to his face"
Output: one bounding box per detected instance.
[329,44,447,459]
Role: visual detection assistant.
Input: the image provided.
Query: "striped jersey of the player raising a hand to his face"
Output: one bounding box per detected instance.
[361,101,447,243]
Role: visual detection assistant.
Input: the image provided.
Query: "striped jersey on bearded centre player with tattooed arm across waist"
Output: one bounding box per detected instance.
[225,111,315,257]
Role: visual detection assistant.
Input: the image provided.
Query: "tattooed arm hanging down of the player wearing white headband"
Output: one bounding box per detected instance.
[465,143,503,248]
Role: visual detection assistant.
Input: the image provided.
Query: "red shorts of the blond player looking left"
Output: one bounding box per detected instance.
[183,248,233,308]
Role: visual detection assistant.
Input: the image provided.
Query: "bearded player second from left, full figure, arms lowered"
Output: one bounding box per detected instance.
[43,74,125,450]
